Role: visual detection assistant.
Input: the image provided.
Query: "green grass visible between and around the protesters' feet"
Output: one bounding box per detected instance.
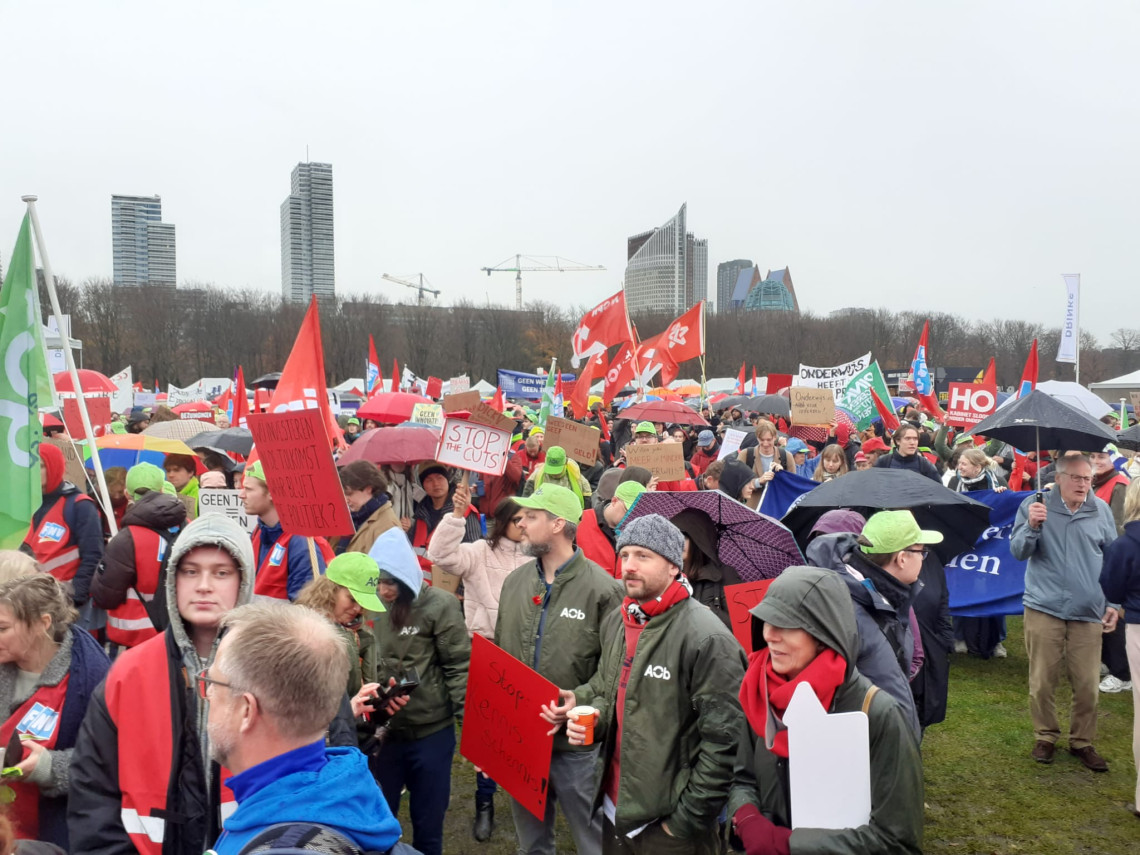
[400,618,1140,855]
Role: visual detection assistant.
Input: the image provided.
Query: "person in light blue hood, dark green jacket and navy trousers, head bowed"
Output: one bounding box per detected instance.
[353,529,471,855]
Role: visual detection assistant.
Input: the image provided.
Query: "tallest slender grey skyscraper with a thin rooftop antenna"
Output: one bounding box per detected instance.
[282,163,336,303]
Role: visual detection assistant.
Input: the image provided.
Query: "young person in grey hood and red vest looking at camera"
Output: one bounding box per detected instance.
[67,514,254,855]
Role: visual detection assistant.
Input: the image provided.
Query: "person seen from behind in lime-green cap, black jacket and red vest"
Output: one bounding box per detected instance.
[91,463,186,648]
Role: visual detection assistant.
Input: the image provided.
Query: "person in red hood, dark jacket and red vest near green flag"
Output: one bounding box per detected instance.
[21,442,103,611]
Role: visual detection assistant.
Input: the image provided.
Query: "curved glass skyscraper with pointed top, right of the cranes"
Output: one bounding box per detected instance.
[625,204,709,315]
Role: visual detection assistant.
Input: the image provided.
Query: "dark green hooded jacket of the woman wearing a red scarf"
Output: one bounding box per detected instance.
[728,568,923,855]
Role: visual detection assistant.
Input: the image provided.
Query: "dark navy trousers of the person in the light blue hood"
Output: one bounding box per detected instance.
[369,725,455,855]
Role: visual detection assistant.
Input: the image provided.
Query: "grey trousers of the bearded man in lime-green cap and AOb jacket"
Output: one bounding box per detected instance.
[511,748,602,855]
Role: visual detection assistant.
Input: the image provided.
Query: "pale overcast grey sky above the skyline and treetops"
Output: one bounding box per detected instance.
[0,0,1140,340]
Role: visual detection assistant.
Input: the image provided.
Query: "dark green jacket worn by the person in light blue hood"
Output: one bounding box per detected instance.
[373,583,471,739]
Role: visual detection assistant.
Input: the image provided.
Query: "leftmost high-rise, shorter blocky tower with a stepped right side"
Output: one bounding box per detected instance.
[111,196,176,286]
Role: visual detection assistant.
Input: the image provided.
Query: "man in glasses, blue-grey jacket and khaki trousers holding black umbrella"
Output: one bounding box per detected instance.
[1010,453,1119,772]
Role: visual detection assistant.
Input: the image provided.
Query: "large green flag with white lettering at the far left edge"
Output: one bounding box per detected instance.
[0,214,51,549]
